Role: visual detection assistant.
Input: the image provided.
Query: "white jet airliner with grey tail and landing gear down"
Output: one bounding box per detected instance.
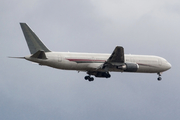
[11,23,171,81]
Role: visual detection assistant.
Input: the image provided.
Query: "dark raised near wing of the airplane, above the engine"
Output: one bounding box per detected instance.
[97,46,124,70]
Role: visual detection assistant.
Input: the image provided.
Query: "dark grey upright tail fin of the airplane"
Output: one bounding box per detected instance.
[20,23,51,54]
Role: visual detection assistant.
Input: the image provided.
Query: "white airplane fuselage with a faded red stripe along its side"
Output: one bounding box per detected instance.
[25,52,171,73]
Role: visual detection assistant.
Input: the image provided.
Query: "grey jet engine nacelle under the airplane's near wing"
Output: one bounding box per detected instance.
[117,63,139,72]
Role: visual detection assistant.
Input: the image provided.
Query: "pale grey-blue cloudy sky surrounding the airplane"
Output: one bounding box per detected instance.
[0,0,180,120]
